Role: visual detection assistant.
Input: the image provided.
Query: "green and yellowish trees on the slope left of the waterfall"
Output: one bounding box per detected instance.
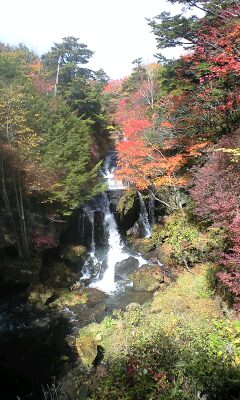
[0,37,107,256]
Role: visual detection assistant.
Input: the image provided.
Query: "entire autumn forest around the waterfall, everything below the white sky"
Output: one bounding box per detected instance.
[0,0,240,400]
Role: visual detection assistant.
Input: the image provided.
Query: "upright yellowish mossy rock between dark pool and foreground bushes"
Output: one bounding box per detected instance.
[76,336,98,368]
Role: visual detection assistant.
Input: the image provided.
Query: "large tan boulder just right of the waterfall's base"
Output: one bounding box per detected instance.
[130,265,165,292]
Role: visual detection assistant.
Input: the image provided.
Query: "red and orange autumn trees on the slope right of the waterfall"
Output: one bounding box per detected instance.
[106,2,240,307]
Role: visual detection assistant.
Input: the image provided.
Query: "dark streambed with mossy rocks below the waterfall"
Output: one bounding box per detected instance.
[0,248,171,400]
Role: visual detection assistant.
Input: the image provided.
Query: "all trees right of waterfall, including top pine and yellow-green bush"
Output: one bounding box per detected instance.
[105,1,240,309]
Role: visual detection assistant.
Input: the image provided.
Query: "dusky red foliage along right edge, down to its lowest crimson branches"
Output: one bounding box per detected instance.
[191,133,240,309]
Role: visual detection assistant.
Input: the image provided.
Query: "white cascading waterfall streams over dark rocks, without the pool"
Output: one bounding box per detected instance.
[81,152,151,293]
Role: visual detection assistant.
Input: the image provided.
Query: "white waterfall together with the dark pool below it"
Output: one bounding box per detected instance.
[0,152,155,400]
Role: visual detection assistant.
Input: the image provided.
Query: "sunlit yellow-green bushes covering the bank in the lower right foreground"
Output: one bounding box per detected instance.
[80,266,240,400]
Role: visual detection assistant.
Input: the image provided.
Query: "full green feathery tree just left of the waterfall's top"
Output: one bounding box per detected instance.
[26,81,106,214]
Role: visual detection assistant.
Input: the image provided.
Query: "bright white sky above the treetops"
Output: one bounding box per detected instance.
[0,0,186,79]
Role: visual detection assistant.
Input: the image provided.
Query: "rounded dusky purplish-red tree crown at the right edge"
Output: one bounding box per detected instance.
[191,136,240,227]
